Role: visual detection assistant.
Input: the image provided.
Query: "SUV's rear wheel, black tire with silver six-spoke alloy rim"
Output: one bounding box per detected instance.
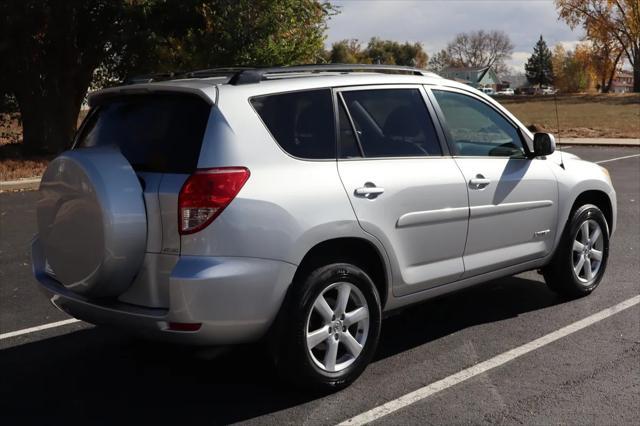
[276,263,381,391]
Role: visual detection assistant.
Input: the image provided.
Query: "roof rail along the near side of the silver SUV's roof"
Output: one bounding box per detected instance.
[229,64,432,86]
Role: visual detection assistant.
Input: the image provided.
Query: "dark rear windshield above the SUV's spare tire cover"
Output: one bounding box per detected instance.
[76,94,211,173]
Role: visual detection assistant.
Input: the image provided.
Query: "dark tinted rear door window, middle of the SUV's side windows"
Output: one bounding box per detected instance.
[341,89,442,157]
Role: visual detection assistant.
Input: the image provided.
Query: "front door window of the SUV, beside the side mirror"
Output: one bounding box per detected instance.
[433,90,524,158]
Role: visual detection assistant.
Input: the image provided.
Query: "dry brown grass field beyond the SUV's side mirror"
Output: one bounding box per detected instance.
[497,93,640,138]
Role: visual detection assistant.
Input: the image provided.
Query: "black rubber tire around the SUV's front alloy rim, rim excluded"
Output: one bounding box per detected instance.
[542,204,609,298]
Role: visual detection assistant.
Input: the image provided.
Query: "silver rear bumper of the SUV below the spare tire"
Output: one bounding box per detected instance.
[32,239,296,345]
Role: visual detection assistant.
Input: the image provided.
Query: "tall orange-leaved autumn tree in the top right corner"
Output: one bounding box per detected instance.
[556,0,640,92]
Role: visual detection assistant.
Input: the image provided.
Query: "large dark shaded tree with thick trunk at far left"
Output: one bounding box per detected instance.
[0,0,125,152]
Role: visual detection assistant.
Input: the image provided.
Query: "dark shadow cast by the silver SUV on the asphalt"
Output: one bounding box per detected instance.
[0,277,561,424]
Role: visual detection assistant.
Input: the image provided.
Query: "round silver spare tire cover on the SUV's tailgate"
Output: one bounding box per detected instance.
[37,148,147,297]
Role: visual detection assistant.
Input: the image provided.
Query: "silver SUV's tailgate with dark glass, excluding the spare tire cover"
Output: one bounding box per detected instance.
[75,92,211,254]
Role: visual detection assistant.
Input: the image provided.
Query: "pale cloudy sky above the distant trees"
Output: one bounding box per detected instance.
[326,0,583,72]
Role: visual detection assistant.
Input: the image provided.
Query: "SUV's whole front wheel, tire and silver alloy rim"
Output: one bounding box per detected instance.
[542,204,609,297]
